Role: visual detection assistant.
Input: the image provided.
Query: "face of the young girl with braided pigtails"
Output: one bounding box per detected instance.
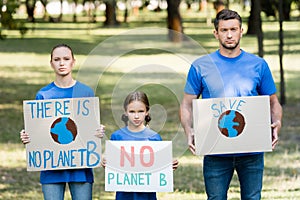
[126,101,148,132]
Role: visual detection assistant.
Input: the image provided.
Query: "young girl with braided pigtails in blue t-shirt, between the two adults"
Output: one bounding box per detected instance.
[104,91,178,200]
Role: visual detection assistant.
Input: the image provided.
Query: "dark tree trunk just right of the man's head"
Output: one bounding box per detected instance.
[247,0,264,57]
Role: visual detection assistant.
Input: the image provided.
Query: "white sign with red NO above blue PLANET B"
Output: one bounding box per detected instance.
[105,141,173,192]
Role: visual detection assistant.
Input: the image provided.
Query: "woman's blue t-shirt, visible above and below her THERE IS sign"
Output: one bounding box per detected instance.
[36,81,95,184]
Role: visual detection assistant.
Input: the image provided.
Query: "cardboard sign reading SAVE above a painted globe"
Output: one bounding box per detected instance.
[193,96,272,155]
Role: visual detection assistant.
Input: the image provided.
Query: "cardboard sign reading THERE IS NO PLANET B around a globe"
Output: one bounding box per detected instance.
[23,97,101,171]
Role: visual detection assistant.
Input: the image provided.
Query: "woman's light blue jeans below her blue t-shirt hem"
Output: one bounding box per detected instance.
[42,182,93,200]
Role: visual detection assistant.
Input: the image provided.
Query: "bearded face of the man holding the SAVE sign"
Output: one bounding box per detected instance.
[214,19,243,50]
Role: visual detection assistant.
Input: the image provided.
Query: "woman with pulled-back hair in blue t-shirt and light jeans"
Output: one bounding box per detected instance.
[20,44,104,200]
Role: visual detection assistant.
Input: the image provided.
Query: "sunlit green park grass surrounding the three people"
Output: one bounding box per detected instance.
[0,5,300,200]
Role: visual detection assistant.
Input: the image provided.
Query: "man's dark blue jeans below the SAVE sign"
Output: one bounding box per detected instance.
[203,153,264,200]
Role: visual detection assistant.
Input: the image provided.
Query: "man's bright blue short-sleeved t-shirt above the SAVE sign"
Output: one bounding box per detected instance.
[184,50,276,99]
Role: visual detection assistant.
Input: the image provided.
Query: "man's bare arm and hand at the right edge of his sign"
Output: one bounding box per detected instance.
[270,94,282,149]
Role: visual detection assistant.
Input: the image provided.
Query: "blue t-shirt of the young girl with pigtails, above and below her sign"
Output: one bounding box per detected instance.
[110,126,162,200]
